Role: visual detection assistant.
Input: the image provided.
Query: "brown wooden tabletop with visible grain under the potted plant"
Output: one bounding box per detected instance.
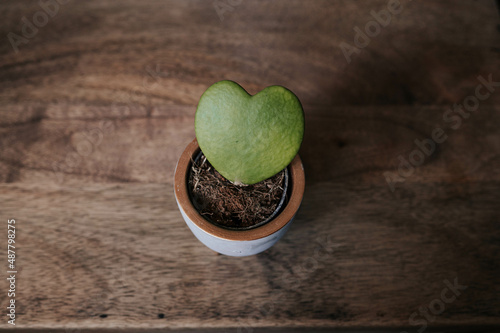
[0,0,500,333]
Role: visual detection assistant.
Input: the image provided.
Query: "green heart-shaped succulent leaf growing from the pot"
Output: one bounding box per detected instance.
[195,81,304,185]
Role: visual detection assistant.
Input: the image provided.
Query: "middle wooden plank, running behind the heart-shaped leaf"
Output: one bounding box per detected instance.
[0,104,500,187]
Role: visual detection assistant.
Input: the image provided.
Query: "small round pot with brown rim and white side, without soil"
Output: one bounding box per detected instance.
[174,139,305,257]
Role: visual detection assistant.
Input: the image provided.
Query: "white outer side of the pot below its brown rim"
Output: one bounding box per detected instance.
[177,197,293,257]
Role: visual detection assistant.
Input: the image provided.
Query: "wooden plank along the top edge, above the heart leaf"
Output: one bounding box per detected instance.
[0,0,500,106]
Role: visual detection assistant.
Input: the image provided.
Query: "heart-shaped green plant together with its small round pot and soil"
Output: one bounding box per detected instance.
[174,81,305,256]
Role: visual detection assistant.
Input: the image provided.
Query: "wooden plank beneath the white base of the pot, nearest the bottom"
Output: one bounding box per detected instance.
[0,176,500,327]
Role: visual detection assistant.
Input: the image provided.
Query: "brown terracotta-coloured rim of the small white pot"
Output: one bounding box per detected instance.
[174,138,305,241]
